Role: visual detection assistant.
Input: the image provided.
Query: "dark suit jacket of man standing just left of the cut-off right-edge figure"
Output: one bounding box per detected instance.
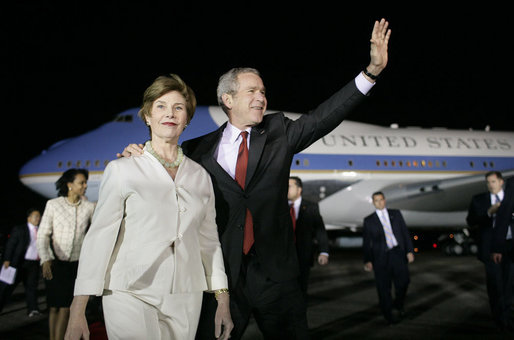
[466,192,493,262]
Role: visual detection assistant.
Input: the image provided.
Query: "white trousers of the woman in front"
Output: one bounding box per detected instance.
[102,291,202,340]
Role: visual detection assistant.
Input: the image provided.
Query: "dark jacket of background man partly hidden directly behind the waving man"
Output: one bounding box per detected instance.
[296,198,329,266]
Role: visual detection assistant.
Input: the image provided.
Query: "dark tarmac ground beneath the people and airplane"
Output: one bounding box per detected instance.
[0,249,514,340]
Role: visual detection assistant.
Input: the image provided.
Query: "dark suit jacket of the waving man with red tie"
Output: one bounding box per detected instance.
[182,80,365,288]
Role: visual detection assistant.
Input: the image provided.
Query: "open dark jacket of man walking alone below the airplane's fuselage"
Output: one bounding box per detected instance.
[362,209,414,266]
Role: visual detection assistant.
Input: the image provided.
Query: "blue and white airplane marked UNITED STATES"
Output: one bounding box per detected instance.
[19,106,514,251]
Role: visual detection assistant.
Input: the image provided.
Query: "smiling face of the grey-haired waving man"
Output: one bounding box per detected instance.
[225,73,267,130]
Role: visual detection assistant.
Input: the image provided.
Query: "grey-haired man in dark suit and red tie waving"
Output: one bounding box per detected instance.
[123,19,391,339]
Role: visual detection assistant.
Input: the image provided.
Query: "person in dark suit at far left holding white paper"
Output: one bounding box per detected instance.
[0,209,41,317]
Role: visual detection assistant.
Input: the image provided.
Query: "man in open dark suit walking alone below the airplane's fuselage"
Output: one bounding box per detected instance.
[363,191,414,324]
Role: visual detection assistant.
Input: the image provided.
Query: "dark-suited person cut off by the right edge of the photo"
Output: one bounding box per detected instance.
[491,173,514,332]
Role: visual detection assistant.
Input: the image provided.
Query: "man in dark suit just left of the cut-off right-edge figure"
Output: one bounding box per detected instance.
[466,171,512,329]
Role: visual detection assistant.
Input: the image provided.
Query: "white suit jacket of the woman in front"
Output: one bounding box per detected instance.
[74,150,228,296]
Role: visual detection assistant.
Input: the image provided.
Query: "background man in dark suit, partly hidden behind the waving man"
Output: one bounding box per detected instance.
[287,176,329,301]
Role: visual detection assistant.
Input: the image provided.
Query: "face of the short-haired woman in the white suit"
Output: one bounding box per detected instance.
[146,91,187,142]
